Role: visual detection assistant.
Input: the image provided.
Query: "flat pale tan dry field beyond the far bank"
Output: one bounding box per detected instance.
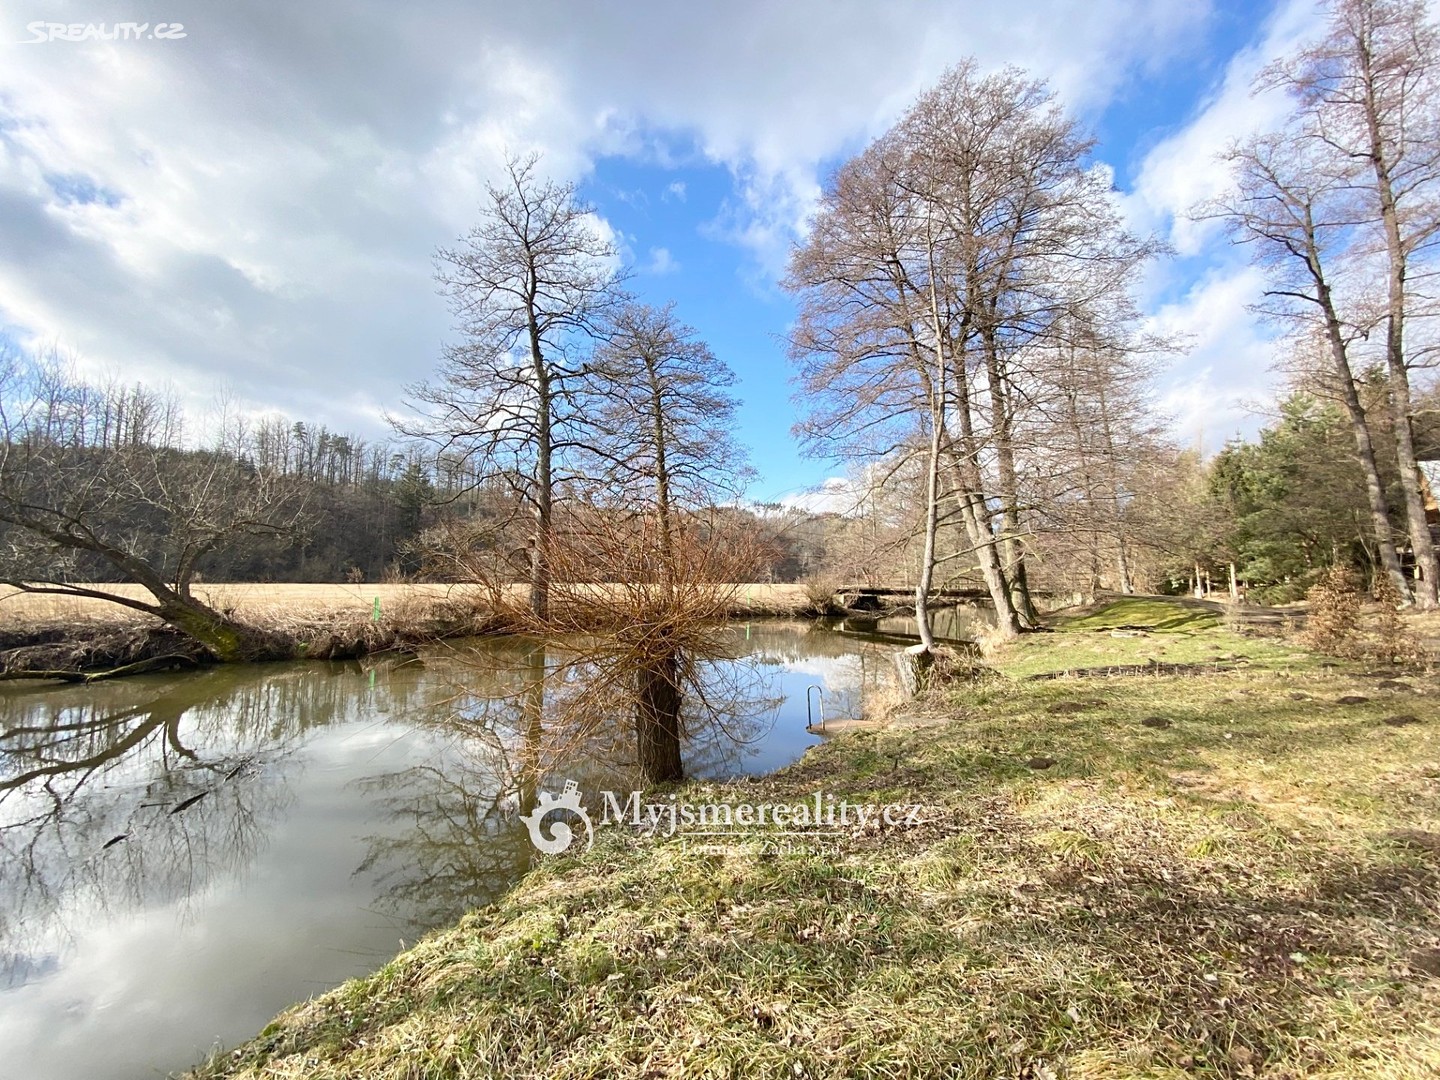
[0,583,808,629]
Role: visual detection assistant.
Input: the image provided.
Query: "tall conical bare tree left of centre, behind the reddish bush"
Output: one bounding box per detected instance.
[395,156,616,618]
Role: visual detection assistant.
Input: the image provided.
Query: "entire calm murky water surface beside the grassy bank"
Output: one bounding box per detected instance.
[0,624,890,1080]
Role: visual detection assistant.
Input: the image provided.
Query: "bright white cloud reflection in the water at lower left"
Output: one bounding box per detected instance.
[0,724,444,1080]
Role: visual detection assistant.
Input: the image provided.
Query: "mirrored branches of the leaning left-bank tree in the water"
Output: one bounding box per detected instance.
[0,668,411,985]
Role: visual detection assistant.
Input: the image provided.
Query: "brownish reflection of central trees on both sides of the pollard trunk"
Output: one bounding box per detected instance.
[356,641,780,927]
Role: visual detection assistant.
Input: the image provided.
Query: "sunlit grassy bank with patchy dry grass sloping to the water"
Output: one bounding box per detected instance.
[194,605,1440,1080]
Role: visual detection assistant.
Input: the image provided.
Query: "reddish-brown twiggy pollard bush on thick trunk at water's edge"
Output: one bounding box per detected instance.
[437,504,763,782]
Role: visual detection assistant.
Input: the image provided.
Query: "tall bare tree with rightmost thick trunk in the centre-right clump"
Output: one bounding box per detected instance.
[897,62,1156,621]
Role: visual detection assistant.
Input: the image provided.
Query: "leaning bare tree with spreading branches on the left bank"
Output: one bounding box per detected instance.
[0,356,304,661]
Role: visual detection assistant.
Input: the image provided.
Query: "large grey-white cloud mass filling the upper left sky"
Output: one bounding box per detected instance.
[0,0,1226,440]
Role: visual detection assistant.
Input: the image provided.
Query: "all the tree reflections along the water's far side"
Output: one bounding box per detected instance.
[0,624,883,986]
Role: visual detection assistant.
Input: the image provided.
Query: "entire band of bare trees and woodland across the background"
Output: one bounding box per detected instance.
[0,0,1440,694]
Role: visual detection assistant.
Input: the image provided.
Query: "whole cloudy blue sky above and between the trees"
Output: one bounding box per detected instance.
[0,0,1342,505]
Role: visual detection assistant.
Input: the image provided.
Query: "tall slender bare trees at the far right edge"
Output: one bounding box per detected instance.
[1201,0,1440,609]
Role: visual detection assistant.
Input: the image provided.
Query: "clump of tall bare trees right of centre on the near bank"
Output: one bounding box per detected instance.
[786,63,1158,659]
